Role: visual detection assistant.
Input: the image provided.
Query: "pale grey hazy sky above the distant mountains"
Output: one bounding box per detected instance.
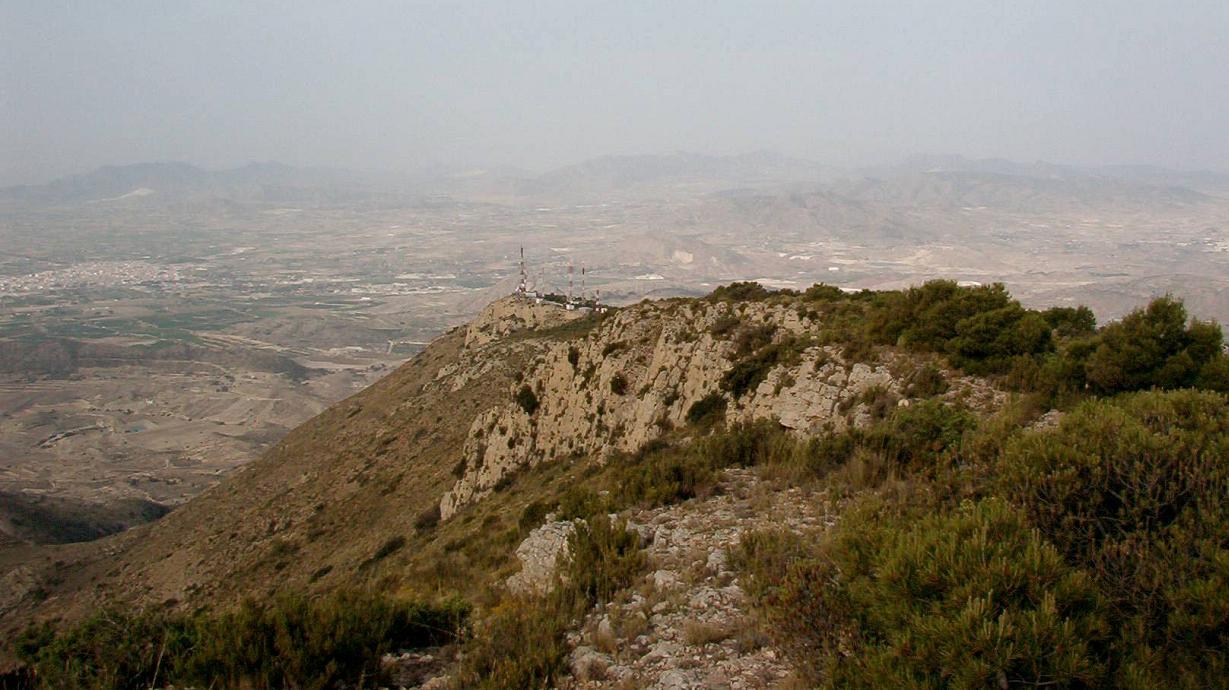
[0,0,1229,184]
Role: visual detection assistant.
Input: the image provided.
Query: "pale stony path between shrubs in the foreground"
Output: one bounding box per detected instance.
[559,470,833,690]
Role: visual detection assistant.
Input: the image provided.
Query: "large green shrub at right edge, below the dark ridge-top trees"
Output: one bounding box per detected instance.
[999,391,1229,688]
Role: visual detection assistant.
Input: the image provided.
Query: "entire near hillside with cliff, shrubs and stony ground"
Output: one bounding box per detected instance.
[9,282,1229,690]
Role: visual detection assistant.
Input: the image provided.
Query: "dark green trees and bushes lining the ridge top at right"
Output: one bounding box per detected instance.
[709,280,1229,400]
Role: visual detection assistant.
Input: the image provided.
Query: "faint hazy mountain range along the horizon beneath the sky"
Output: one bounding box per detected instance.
[0,153,1229,208]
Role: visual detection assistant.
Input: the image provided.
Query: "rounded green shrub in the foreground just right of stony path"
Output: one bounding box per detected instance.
[737,499,1109,689]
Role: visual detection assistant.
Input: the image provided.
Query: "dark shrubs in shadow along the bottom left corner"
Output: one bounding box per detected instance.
[16,592,469,690]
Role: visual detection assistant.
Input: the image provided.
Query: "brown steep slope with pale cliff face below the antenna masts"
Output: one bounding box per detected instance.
[0,292,999,627]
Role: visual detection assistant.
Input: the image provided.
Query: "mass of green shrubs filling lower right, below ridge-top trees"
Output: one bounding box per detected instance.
[740,391,1229,689]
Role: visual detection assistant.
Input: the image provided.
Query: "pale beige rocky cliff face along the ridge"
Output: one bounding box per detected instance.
[440,299,999,519]
